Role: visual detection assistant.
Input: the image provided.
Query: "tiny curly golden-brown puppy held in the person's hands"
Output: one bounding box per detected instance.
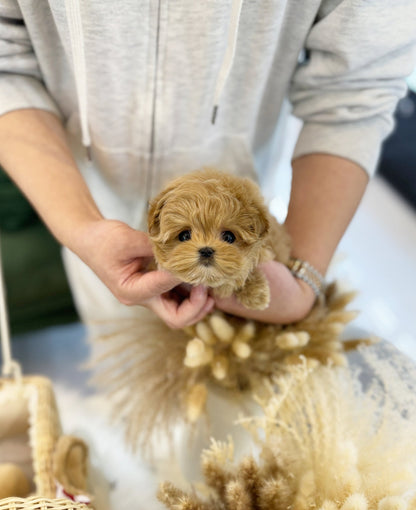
[148,169,290,310]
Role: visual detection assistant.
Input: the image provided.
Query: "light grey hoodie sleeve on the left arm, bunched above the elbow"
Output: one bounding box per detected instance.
[0,0,60,116]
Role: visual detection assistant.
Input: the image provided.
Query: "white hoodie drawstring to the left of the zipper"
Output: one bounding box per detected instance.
[65,0,91,160]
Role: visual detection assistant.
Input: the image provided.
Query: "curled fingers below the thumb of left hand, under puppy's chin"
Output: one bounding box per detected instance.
[149,286,214,329]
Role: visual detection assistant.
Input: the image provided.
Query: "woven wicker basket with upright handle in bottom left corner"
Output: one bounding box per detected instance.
[0,232,91,510]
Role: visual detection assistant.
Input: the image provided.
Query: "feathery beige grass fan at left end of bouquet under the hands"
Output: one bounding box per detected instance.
[90,308,197,455]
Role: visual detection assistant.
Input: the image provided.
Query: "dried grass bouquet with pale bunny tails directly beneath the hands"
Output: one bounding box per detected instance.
[94,285,370,451]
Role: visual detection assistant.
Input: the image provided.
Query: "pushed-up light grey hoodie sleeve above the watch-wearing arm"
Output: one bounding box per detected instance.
[289,0,416,175]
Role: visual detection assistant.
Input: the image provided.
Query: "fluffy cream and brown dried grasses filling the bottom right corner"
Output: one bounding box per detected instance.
[158,346,416,510]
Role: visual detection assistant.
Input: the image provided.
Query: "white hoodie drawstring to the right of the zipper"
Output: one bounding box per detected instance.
[211,0,243,124]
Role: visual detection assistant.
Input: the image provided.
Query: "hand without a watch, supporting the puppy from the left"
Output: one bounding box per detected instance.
[74,219,214,328]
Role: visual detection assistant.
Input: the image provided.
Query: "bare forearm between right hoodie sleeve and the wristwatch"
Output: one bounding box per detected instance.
[285,154,368,274]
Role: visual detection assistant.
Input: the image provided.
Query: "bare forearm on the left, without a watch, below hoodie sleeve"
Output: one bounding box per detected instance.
[0,109,102,251]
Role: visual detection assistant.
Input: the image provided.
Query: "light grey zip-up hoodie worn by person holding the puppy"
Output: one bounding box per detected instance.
[0,0,416,226]
